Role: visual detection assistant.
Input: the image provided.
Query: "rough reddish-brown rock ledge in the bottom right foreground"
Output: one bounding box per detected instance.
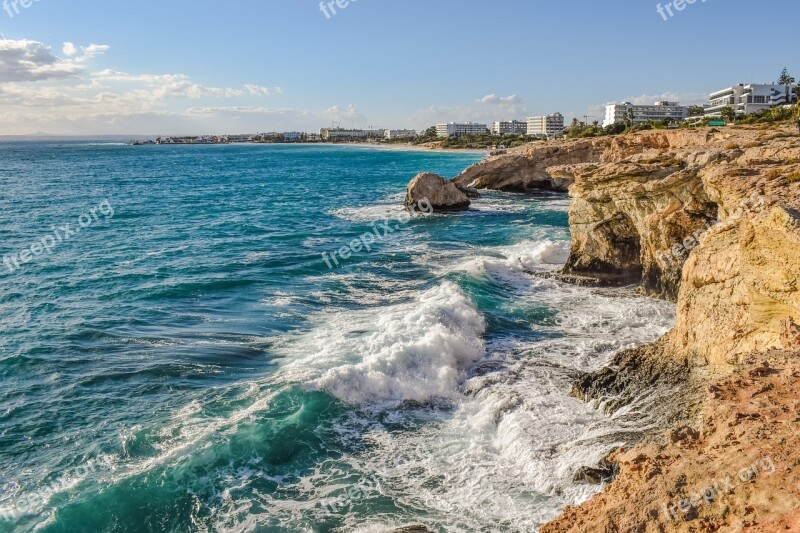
[540,352,800,533]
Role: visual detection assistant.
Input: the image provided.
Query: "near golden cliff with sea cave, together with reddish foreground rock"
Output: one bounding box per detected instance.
[542,128,800,533]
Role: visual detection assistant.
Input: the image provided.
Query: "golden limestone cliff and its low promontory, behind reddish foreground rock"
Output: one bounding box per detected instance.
[454,128,800,370]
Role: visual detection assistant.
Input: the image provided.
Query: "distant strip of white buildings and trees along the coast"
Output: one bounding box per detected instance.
[131,80,798,147]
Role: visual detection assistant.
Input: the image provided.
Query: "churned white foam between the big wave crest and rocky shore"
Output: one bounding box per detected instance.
[344,272,673,531]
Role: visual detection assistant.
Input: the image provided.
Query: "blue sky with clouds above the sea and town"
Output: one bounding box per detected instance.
[0,0,800,136]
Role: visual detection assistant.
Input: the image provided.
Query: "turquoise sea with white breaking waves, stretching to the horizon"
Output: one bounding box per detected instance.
[0,142,673,532]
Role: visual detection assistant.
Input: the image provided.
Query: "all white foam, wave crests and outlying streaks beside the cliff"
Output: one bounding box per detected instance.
[45,196,674,532]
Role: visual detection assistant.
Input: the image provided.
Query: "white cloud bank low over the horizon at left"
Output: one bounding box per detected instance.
[0,39,294,135]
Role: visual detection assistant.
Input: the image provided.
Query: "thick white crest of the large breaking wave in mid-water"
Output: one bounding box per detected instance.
[278,282,485,403]
